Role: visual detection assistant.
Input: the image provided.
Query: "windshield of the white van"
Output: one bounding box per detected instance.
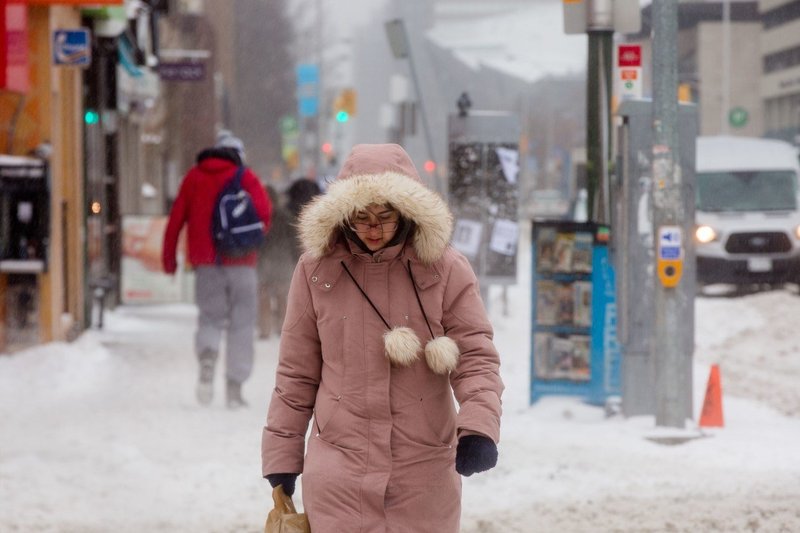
[696,170,797,211]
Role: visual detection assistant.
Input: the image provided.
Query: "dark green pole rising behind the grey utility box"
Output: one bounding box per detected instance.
[586,0,614,224]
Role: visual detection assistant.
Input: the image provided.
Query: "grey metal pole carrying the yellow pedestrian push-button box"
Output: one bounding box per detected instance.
[653,0,691,428]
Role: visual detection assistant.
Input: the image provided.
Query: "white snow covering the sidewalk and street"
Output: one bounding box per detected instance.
[0,225,800,533]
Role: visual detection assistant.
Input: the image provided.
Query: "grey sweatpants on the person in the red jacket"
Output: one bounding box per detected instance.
[195,265,258,383]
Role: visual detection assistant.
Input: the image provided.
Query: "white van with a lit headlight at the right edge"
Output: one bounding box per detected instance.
[695,137,800,286]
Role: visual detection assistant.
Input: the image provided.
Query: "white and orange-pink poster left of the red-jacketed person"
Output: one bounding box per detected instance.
[121,215,186,304]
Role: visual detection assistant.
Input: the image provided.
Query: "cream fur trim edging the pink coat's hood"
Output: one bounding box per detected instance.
[298,172,453,264]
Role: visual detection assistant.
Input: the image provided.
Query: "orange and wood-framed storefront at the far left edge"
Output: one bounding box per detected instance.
[0,5,86,351]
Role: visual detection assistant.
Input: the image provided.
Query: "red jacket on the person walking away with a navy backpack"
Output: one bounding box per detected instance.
[161,150,272,274]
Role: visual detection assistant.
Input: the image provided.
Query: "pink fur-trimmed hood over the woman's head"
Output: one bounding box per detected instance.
[299,144,453,264]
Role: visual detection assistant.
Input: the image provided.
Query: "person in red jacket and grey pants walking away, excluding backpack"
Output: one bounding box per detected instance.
[162,135,272,408]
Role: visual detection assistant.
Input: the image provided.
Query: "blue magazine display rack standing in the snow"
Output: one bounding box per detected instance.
[531,221,620,404]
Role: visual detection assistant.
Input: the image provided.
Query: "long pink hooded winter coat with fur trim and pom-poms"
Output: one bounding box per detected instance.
[262,145,503,533]
